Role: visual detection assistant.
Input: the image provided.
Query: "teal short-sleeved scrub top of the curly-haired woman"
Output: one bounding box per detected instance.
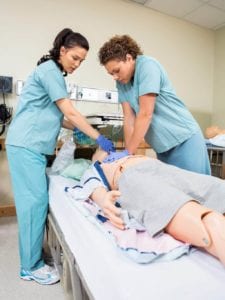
[117,55,199,153]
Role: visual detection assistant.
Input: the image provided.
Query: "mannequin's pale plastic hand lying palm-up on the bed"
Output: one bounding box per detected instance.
[98,190,125,229]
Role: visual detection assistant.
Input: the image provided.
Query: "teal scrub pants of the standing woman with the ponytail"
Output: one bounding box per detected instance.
[6,145,48,271]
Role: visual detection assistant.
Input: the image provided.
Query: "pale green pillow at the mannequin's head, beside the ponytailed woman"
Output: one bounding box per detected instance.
[60,158,92,180]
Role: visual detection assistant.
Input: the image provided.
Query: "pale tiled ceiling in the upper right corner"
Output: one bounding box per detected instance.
[129,0,225,30]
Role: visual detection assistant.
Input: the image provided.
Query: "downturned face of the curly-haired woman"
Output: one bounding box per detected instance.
[104,54,135,84]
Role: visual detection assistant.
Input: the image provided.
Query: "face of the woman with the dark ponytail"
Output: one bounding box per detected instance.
[59,46,87,74]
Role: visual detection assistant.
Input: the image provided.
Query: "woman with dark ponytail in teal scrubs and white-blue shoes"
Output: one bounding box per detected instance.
[6,28,114,284]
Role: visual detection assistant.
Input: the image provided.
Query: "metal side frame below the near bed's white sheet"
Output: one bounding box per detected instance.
[46,208,94,300]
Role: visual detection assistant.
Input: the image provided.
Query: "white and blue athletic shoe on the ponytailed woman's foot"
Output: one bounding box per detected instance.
[20,265,60,284]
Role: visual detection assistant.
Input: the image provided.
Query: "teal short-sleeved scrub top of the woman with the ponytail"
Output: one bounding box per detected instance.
[6,60,68,154]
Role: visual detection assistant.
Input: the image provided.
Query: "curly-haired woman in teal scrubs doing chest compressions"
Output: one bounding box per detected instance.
[99,35,210,174]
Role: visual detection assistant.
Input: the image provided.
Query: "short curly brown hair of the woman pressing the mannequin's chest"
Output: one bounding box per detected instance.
[98,35,143,65]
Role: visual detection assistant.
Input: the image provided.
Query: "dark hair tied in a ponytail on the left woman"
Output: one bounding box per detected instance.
[37,28,89,71]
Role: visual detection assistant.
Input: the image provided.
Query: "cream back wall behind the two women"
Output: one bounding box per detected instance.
[0,0,215,122]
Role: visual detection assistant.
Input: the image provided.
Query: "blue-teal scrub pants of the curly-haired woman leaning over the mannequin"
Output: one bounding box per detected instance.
[157,131,211,175]
